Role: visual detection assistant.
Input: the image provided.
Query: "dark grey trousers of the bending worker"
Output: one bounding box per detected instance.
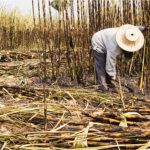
[92,50,111,88]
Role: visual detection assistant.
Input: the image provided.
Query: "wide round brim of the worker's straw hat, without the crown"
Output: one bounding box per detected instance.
[116,24,144,52]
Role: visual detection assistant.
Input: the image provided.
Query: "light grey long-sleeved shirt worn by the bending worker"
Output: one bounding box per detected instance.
[92,28,122,78]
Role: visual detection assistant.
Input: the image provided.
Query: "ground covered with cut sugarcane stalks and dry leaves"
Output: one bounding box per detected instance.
[0,51,150,150]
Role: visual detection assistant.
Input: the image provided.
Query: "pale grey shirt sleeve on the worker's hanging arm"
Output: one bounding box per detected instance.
[106,51,117,79]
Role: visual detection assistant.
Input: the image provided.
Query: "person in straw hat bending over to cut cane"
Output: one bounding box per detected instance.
[92,24,145,91]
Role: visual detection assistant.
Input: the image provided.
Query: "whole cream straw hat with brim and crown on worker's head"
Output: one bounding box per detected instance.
[116,24,144,52]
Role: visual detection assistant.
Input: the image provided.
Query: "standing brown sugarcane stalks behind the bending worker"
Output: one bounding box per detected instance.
[0,0,150,88]
